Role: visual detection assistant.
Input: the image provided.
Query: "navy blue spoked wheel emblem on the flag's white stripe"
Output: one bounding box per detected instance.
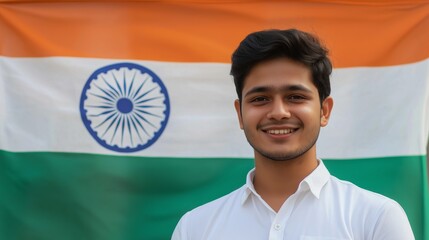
[80,63,170,152]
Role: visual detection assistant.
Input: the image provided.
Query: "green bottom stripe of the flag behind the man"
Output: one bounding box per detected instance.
[0,151,429,240]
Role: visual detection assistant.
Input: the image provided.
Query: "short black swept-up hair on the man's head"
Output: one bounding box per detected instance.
[231,29,332,103]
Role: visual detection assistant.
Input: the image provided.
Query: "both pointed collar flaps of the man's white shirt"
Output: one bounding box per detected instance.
[241,159,331,204]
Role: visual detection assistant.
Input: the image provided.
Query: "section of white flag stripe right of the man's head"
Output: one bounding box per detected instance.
[317,60,429,158]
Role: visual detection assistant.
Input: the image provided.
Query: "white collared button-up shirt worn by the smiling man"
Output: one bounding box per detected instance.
[172,161,414,240]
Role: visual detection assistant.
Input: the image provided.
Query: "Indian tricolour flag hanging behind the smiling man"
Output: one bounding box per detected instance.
[0,0,429,240]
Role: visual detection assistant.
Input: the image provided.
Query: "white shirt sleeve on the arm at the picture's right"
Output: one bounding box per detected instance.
[372,200,415,240]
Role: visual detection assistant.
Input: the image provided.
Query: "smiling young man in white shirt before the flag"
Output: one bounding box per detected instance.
[172,29,414,240]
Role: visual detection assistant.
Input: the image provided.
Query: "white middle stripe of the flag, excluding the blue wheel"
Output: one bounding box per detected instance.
[0,57,429,158]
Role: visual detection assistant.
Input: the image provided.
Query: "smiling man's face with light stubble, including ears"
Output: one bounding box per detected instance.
[235,58,333,161]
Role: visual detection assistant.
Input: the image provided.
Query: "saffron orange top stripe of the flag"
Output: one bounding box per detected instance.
[0,1,429,67]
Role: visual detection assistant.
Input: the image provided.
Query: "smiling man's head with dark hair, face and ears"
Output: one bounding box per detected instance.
[231,30,333,161]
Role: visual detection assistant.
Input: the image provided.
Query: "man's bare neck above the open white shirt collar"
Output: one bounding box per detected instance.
[253,149,318,212]
